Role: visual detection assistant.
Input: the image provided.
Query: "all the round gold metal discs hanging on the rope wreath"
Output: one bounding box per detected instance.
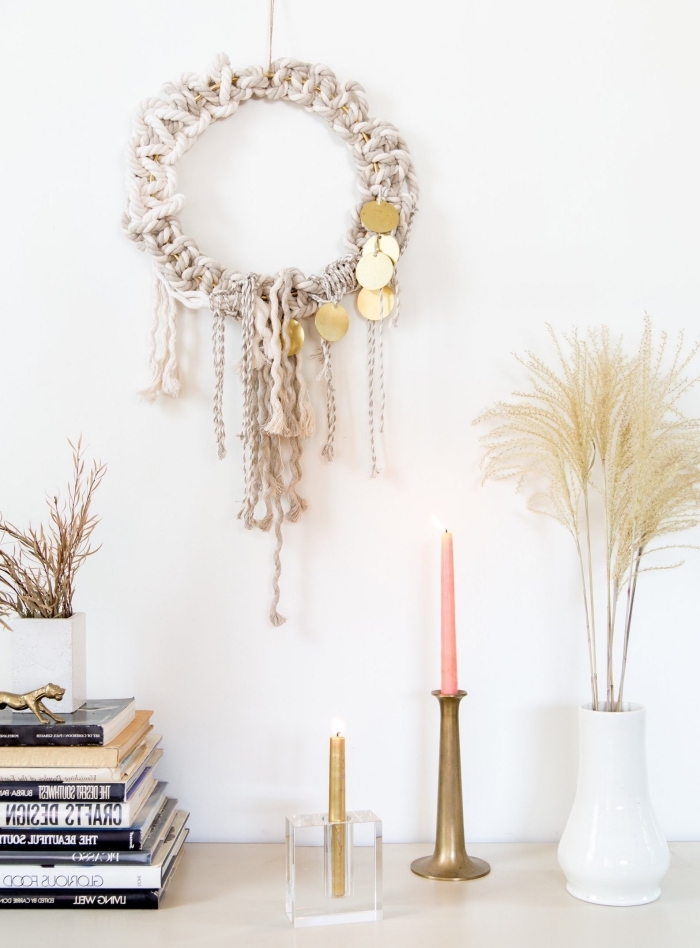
[287,201,399,356]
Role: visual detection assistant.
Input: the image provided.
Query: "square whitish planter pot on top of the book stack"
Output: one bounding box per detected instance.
[6,612,87,715]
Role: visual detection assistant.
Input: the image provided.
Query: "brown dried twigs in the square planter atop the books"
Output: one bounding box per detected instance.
[0,439,106,624]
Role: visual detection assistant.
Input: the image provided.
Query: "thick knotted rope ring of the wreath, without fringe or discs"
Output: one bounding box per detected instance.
[123,54,418,308]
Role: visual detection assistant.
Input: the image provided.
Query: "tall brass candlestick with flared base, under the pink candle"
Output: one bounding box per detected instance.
[411,691,491,882]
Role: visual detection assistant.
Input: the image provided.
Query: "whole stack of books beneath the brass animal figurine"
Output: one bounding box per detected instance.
[0,698,189,909]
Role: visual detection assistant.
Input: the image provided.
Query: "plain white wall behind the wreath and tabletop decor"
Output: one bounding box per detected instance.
[0,0,700,840]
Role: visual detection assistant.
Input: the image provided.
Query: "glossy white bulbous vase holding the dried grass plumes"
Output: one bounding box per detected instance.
[559,703,669,905]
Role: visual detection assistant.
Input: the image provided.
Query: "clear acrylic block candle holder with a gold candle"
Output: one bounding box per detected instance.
[287,810,382,928]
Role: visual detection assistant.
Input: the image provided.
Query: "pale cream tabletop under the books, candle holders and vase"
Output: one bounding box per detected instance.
[0,843,700,948]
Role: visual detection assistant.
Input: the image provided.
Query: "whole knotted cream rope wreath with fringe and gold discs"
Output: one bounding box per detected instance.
[123,55,418,625]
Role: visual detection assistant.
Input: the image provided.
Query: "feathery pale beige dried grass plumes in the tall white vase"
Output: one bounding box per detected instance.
[476,319,700,710]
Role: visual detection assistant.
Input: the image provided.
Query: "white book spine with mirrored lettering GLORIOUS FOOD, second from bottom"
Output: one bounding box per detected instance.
[0,865,161,891]
